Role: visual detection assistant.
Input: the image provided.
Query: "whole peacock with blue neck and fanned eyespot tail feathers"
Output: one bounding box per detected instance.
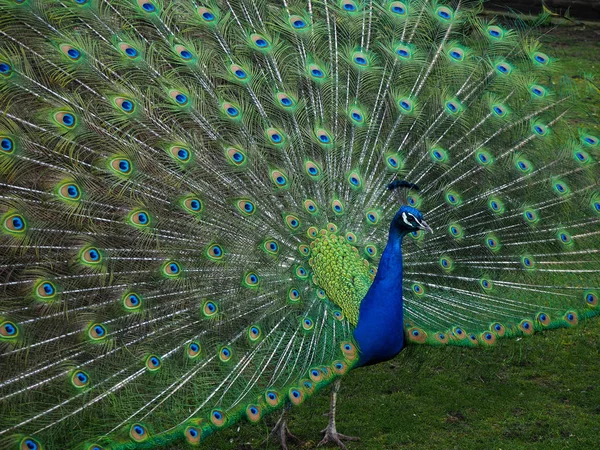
[0,0,600,450]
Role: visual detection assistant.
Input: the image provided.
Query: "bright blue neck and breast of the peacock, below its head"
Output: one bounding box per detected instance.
[354,224,406,366]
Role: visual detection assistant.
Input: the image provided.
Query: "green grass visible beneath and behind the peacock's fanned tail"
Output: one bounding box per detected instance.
[175,17,600,450]
